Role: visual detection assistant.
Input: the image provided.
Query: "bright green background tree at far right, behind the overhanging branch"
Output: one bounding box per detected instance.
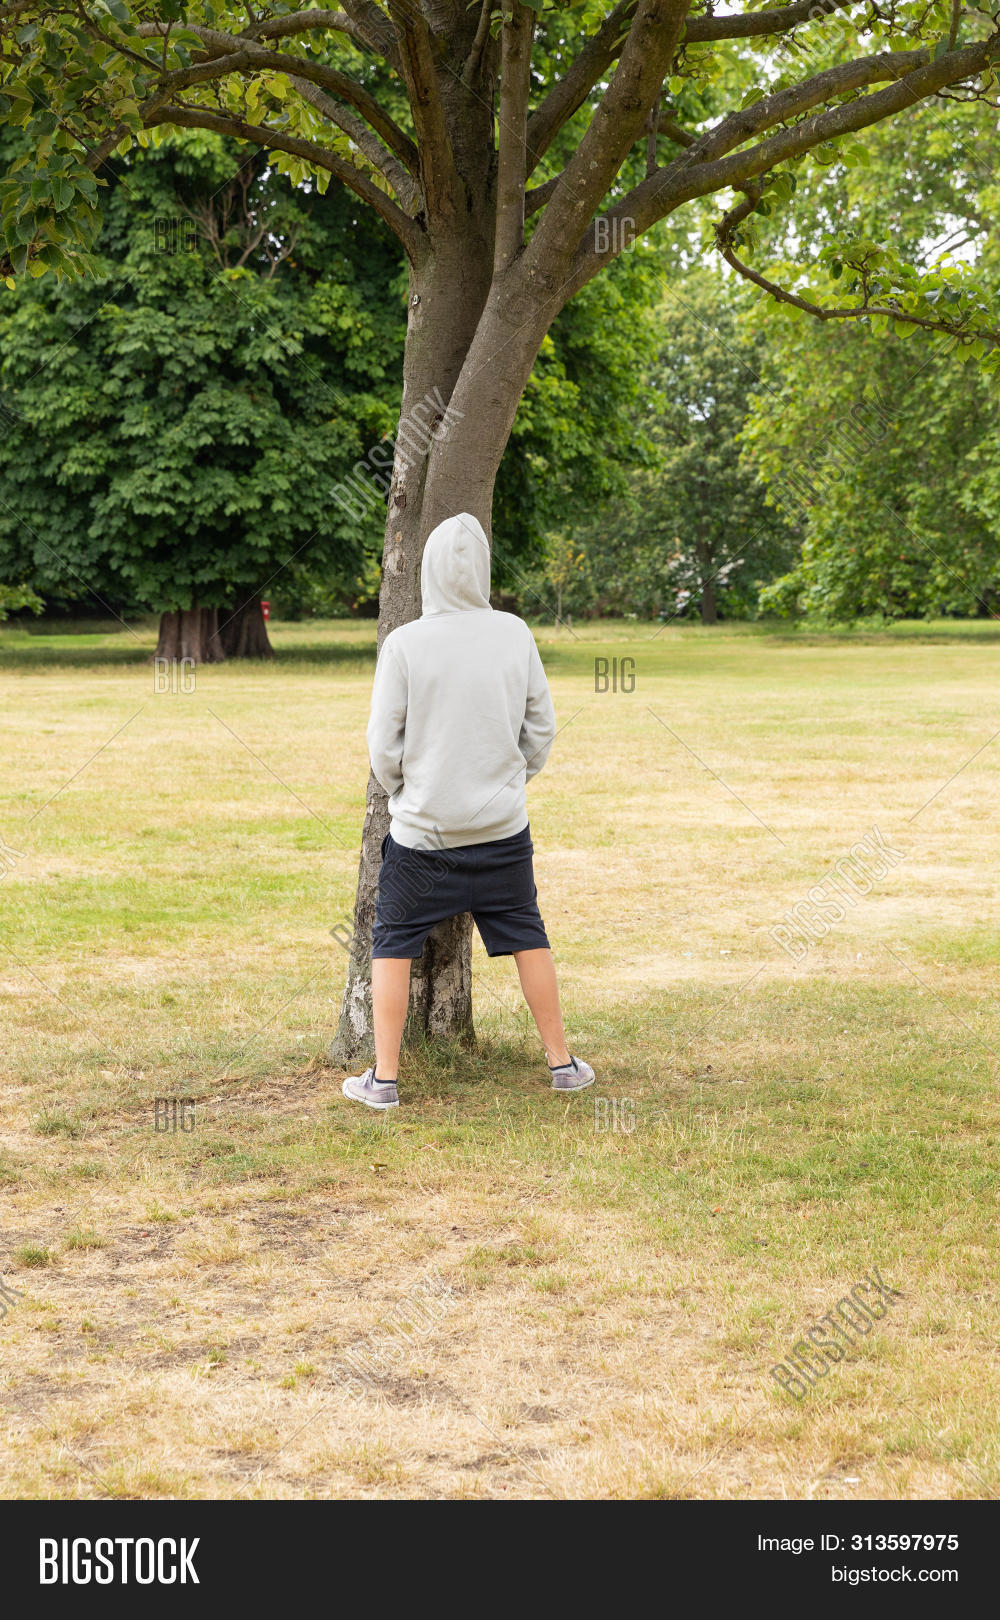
[744,107,1000,619]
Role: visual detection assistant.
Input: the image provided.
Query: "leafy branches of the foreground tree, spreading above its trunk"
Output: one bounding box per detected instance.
[0,0,1000,366]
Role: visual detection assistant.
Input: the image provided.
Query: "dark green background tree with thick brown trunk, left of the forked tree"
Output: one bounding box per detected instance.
[0,133,404,661]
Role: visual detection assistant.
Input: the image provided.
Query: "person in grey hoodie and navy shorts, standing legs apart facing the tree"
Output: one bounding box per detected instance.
[344,512,593,1108]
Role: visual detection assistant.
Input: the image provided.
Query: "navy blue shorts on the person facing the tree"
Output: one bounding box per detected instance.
[371,826,548,957]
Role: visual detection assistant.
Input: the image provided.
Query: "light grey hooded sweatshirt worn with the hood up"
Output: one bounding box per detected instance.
[368,512,556,849]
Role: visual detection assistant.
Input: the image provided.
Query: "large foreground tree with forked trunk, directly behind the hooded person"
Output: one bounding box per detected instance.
[0,0,1000,1059]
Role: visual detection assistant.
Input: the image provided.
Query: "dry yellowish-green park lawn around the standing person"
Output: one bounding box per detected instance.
[0,622,1000,1499]
